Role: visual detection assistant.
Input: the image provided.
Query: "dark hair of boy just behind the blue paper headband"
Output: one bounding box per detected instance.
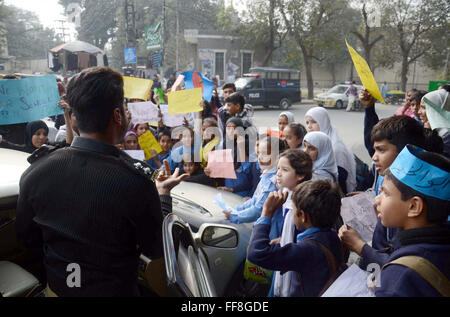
[371,116,431,153]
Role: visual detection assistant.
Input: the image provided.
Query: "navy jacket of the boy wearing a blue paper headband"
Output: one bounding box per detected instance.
[375,226,450,297]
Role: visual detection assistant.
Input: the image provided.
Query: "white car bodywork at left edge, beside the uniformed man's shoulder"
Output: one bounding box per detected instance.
[0,149,30,198]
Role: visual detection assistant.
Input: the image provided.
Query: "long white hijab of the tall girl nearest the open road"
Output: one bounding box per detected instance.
[305,107,356,193]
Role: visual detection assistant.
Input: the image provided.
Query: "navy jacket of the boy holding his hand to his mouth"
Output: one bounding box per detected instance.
[248,224,342,297]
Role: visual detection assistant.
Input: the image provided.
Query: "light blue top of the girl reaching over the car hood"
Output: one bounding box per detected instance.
[230,167,283,239]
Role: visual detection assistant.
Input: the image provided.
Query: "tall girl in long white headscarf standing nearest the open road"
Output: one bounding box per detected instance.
[305,107,356,194]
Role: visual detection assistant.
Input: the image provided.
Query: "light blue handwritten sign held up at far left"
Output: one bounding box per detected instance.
[0,75,63,125]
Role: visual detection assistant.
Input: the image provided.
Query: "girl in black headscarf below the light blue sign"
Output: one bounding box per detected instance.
[0,121,49,154]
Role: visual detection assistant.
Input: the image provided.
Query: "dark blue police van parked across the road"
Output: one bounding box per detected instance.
[235,67,302,110]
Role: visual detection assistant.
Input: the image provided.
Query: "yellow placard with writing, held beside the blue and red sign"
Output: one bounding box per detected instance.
[169,88,203,115]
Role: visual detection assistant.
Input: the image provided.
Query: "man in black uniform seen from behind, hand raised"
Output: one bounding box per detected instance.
[16,67,185,297]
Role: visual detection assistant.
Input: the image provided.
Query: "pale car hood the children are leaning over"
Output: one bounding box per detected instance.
[171,182,244,217]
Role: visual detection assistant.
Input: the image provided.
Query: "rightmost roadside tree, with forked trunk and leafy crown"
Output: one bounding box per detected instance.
[383,0,449,90]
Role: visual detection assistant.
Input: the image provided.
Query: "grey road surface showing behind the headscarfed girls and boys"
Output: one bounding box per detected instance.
[253,101,399,164]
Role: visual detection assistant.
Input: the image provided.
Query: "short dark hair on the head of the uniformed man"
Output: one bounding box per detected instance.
[67,67,124,133]
